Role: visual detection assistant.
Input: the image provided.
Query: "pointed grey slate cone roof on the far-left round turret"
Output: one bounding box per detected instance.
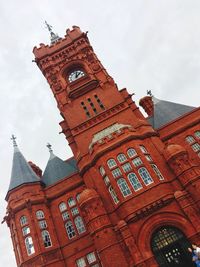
[8,146,40,191]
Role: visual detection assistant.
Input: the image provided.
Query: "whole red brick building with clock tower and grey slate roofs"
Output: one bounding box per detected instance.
[5,26,200,267]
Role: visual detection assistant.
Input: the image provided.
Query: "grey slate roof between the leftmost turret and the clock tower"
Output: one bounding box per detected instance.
[42,152,78,186]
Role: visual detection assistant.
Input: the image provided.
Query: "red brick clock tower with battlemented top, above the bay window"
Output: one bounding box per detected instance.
[33,26,152,174]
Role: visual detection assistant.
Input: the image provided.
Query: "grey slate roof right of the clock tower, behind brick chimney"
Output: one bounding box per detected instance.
[148,97,195,129]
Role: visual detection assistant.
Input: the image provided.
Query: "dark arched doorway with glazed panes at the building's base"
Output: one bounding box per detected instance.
[151,226,195,267]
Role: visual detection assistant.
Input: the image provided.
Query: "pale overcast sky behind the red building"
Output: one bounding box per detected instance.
[0,0,200,267]
